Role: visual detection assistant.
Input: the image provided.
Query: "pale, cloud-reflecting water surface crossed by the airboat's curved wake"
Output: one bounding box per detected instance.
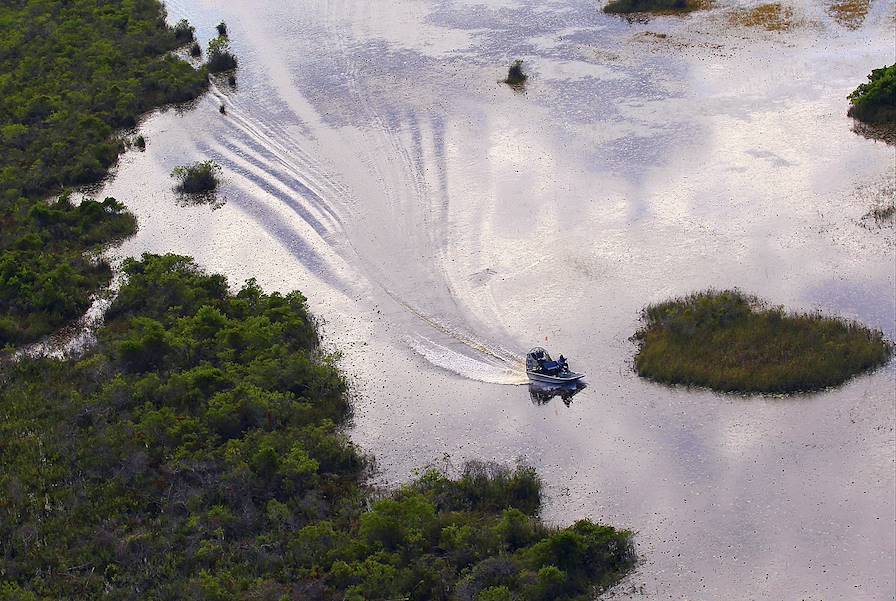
[94,0,896,599]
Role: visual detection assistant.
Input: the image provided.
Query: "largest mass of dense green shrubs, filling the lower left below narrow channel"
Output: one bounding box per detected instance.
[0,255,633,601]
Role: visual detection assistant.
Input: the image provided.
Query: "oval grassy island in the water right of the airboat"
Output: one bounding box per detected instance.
[635,291,892,393]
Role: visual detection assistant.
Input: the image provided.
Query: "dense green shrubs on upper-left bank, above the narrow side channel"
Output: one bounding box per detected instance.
[0,0,207,347]
